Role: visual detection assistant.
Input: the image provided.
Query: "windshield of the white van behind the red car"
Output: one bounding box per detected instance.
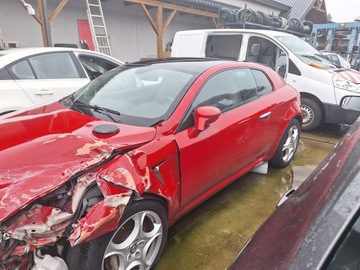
[276,36,336,69]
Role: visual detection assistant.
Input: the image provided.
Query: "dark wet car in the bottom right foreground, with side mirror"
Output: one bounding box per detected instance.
[228,97,360,270]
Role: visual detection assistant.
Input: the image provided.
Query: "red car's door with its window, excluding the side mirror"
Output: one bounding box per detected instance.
[175,69,268,207]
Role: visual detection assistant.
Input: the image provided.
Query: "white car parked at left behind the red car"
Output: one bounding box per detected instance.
[0,48,123,115]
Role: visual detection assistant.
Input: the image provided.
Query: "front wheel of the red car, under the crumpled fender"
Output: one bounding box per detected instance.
[67,200,167,270]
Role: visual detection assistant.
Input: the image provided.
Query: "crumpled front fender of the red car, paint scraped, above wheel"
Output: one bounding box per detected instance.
[69,152,150,246]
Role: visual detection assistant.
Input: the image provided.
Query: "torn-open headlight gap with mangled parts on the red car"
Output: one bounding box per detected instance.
[0,168,132,269]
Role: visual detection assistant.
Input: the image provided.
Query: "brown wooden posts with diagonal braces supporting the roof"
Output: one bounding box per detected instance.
[18,0,219,58]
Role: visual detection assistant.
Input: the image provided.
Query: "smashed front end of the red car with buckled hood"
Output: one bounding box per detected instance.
[0,104,162,265]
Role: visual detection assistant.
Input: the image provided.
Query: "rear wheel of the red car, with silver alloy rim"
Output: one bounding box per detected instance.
[269,119,300,168]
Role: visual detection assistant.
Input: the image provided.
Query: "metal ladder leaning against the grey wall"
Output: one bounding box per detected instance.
[85,0,111,55]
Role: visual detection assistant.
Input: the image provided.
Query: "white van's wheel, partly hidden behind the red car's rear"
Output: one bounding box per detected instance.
[301,98,323,131]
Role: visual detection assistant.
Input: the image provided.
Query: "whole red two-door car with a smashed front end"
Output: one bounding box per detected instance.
[0,59,302,270]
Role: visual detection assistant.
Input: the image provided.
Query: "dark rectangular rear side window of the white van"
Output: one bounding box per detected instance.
[205,35,242,60]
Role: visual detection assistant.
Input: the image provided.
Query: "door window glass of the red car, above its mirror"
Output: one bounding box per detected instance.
[193,69,258,112]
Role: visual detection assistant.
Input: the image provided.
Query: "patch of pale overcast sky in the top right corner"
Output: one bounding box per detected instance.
[325,0,360,22]
